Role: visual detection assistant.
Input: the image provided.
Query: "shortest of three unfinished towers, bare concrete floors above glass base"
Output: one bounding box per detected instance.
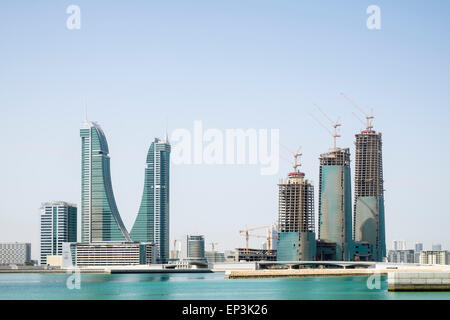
[277,153,316,261]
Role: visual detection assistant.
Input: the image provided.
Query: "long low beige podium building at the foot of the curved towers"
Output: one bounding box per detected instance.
[64,242,155,267]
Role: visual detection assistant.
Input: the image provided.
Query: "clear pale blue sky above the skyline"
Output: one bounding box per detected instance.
[0,0,450,258]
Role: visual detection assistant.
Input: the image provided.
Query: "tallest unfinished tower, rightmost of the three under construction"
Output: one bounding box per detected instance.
[353,116,384,261]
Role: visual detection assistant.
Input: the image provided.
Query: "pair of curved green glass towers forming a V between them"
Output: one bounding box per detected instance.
[80,121,170,263]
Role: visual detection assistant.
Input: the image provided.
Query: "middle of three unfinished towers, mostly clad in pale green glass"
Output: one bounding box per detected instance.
[319,147,353,261]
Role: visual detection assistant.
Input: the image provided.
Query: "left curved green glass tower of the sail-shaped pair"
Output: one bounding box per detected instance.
[80,121,131,242]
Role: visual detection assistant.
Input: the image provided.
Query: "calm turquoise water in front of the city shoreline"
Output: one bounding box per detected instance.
[0,273,450,300]
